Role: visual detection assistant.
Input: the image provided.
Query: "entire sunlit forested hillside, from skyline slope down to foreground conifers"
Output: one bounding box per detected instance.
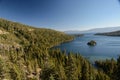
[0,19,111,80]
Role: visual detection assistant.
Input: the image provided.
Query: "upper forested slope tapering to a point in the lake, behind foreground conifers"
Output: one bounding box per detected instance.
[0,19,73,48]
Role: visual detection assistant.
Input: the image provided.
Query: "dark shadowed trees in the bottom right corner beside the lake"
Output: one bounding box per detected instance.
[95,57,120,80]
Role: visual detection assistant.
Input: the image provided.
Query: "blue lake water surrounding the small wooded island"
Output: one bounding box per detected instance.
[56,34,120,62]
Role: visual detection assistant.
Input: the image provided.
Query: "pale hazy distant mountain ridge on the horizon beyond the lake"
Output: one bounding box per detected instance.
[65,26,120,34]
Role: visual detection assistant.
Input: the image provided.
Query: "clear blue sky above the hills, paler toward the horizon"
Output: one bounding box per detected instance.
[0,0,120,31]
